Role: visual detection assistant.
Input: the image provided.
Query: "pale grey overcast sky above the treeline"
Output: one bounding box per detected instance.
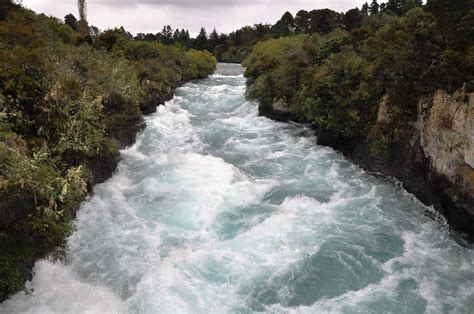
[23,0,370,35]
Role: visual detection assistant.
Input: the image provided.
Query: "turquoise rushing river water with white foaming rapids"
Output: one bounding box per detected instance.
[0,65,474,313]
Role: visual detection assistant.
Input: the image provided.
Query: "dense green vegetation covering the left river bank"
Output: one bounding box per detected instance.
[0,0,216,301]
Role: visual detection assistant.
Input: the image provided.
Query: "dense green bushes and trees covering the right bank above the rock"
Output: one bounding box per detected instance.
[244,0,474,158]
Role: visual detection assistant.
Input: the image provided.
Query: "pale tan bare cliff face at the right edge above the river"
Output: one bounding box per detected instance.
[416,89,474,235]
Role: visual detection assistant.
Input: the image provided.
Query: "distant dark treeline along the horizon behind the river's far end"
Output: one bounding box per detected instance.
[103,0,422,63]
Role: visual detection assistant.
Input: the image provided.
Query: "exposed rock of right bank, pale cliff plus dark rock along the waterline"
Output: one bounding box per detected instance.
[261,89,474,236]
